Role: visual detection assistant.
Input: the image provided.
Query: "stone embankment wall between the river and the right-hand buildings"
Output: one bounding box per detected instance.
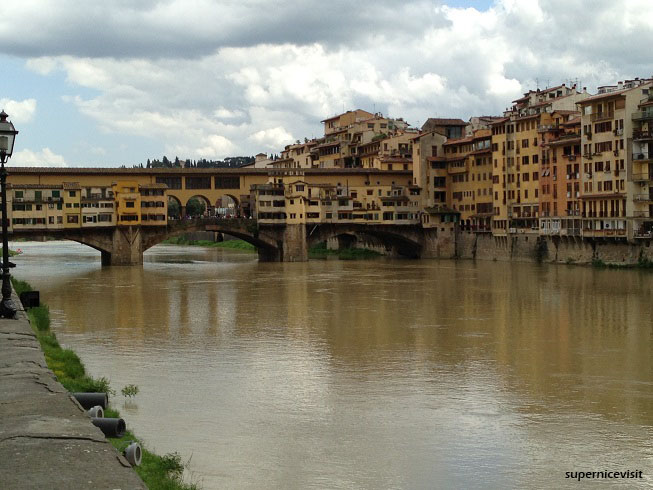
[456,232,653,265]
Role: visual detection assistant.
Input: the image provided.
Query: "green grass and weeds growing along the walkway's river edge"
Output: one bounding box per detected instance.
[11,277,198,490]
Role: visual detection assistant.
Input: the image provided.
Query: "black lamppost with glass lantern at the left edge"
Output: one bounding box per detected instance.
[0,110,18,318]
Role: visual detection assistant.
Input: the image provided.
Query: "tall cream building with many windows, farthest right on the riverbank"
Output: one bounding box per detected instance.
[578,79,653,240]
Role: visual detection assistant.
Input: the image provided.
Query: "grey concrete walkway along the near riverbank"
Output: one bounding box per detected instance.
[0,297,147,490]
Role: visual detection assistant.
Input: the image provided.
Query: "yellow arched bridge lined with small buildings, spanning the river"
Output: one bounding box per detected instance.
[7,168,455,265]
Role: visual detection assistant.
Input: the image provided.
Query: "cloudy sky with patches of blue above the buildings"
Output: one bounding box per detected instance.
[0,0,653,166]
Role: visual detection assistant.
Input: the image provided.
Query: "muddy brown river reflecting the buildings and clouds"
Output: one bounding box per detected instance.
[12,242,653,489]
